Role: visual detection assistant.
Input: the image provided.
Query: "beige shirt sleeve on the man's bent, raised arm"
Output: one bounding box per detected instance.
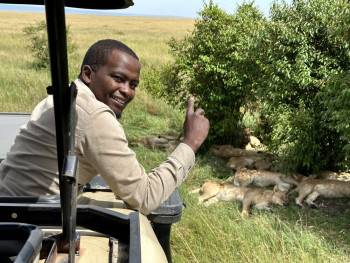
[81,111,195,214]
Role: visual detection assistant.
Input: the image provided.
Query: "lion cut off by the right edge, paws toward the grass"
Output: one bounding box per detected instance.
[291,179,350,207]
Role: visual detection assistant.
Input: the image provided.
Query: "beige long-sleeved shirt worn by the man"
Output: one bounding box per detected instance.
[0,80,195,214]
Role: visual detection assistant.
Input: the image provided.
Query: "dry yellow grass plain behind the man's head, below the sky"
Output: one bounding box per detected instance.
[0,11,194,111]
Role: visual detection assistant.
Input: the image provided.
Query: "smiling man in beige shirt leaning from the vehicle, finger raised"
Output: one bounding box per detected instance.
[0,39,209,217]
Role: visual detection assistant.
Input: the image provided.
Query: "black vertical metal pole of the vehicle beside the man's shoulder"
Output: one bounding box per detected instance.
[45,0,77,262]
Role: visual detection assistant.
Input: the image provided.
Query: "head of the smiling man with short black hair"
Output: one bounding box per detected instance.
[80,40,141,118]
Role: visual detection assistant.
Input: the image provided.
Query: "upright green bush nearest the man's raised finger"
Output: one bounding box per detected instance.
[162,2,264,145]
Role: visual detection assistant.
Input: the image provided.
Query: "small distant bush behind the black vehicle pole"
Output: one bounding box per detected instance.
[23,21,77,69]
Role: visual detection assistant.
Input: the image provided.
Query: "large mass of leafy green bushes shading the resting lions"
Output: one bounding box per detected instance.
[157,0,350,173]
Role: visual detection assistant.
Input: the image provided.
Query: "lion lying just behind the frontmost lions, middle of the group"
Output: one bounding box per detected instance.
[233,168,299,191]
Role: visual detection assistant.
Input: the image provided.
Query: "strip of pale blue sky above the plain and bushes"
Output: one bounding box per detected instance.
[0,0,290,18]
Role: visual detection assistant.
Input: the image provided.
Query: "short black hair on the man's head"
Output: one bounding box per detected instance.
[80,39,139,74]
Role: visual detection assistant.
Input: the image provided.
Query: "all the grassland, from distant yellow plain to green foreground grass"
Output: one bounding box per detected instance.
[0,12,350,263]
